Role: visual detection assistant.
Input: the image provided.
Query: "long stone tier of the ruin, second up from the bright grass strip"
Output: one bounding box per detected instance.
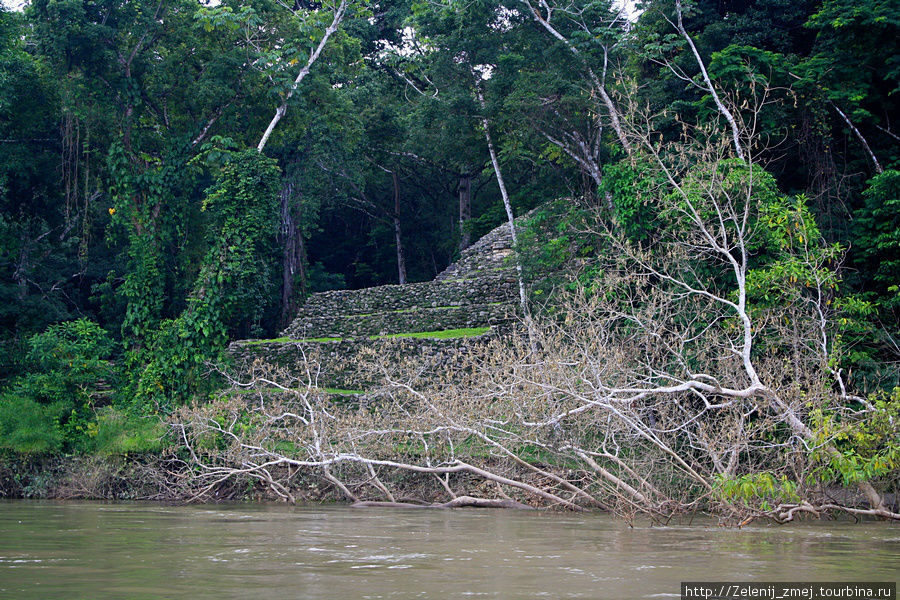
[286,270,518,331]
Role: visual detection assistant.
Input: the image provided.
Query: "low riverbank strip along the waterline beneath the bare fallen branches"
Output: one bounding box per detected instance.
[0,454,900,527]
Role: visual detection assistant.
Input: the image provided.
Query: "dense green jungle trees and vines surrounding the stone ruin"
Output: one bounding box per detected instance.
[0,0,900,510]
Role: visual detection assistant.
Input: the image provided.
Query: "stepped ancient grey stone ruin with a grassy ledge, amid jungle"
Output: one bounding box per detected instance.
[229,218,519,394]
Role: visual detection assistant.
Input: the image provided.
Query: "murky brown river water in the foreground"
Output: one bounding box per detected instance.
[0,501,900,600]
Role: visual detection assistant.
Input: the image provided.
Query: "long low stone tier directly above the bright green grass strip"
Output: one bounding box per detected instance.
[283,301,518,339]
